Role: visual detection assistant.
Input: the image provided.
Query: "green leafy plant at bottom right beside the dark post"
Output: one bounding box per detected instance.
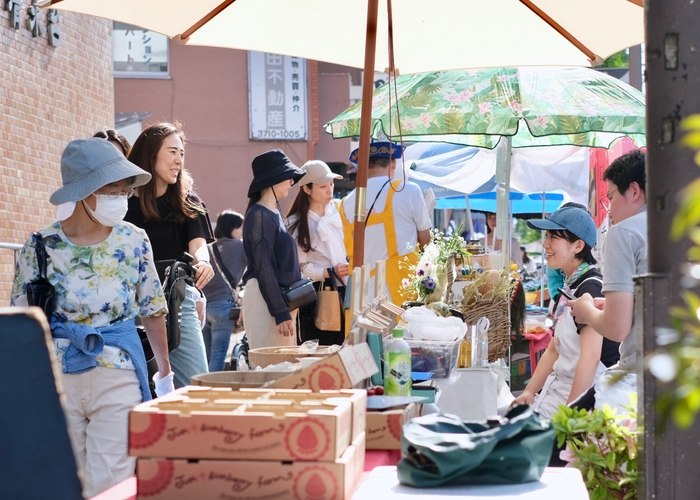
[552,398,637,500]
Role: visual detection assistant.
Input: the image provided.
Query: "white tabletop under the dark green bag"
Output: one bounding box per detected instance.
[352,467,589,500]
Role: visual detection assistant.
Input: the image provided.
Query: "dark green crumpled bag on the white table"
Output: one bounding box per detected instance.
[398,405,554,488]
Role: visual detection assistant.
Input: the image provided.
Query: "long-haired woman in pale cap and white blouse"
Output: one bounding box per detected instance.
[288,160,348,345]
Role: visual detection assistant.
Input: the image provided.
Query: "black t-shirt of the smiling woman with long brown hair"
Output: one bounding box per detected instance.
[124,193,214,280]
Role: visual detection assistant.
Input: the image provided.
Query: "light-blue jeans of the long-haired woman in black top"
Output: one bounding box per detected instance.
[170,285,209,389]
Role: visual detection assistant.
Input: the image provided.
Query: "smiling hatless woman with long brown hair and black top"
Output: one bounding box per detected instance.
[126,123,214,388]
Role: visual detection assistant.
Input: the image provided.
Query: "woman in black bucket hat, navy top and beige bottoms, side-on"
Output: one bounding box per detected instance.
[243,149,304,349]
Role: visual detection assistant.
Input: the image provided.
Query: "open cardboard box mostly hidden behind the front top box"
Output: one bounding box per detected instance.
[160,386,367,441]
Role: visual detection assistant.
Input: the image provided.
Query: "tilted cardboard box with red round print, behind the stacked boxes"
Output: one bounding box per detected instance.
[266,342,379,392]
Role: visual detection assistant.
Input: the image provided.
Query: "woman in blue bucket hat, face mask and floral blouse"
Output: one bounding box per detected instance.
[12,138,173,497]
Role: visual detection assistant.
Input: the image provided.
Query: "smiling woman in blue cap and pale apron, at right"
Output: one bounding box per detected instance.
[514,207,619,418]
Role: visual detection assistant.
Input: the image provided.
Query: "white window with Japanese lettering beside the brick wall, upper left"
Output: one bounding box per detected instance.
[112,21,170,78]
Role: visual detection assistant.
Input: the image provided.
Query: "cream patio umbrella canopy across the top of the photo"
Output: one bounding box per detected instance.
[40,0,644,74]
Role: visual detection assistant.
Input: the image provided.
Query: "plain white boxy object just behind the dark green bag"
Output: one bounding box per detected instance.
[435,367,513,420]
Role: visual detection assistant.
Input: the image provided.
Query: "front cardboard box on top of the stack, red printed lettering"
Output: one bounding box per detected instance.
[129,393,352,462]
